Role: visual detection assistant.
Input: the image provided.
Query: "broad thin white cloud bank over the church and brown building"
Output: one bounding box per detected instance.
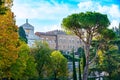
[12,0,75,32]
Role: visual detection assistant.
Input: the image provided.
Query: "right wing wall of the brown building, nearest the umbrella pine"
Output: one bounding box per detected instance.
[58,35,82,51]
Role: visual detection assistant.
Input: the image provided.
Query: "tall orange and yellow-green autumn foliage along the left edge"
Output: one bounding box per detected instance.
[0,0,36,80]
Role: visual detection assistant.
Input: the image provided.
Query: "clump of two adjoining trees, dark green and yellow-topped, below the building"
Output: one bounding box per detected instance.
[31,41,67,80]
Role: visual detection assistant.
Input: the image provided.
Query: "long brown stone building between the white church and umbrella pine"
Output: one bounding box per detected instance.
[35,30,83,52]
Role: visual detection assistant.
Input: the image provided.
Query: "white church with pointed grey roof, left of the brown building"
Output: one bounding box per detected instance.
[21,19,40,47]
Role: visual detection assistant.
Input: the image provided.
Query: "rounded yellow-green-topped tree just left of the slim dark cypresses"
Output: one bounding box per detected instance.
[51,51,68,80]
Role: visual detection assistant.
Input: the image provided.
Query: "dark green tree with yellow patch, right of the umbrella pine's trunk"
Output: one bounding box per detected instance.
[89,29,119,80]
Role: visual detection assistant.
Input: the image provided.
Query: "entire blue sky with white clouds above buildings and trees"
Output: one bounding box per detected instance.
[12,0,120,32]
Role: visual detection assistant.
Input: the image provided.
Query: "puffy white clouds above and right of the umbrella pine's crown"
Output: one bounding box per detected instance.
[78,1,120,27]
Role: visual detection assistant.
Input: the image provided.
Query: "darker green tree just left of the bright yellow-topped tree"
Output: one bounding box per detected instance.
[31,42,51,78]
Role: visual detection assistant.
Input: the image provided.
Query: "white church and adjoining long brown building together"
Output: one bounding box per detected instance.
[21,19,83,52]
